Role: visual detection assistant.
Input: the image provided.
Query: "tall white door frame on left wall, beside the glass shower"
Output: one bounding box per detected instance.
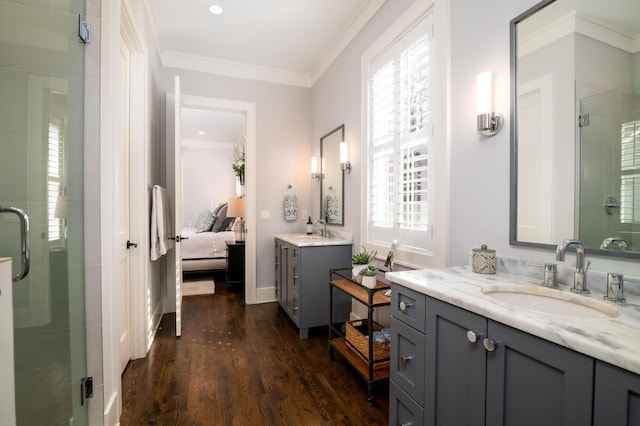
[100,0,151,424]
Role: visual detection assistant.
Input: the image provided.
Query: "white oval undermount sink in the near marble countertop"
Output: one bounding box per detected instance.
[482,284,620,318]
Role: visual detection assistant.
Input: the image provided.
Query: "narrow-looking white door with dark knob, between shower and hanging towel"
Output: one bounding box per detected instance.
[116,39,131,373]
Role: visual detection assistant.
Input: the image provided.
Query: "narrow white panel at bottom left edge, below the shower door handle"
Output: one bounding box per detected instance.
[0,258,16,425]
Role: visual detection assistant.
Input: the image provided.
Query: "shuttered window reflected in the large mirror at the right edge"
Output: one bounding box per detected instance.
[620,121,640,224]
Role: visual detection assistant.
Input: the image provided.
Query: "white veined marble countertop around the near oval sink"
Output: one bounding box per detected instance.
[386,266,640,374]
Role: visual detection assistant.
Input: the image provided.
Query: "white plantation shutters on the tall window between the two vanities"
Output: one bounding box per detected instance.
[367,15,433,252]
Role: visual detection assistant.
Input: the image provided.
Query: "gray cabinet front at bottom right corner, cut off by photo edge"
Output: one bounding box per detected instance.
[593,361,640,426]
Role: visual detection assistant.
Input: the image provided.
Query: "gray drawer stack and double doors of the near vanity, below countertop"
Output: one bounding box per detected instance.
[389,285,594,426]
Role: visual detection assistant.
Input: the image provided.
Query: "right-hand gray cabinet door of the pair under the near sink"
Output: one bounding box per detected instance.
[486,320,594,426]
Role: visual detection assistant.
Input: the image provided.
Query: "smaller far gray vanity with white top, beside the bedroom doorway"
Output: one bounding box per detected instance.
[275,234,353,339]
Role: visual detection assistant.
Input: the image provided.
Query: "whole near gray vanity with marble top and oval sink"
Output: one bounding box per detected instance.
[387,267,640,425]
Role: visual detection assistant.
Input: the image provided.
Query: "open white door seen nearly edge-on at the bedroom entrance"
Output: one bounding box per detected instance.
[166,76,182,337]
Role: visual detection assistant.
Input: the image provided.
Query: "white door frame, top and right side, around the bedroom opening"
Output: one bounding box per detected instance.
[176,93,257,304]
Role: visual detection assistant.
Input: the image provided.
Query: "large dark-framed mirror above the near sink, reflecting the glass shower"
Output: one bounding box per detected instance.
[510,0,640,258]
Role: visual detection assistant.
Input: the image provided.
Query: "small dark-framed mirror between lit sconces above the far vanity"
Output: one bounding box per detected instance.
[320,124,344,226]
